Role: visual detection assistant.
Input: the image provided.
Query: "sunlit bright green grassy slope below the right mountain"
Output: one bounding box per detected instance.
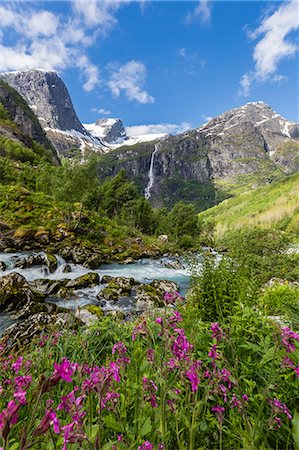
[199,174,299,235]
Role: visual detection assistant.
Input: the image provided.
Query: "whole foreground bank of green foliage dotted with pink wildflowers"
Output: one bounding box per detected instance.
[0,298,299,450]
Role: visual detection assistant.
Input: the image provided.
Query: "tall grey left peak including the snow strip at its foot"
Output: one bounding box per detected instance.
[1,69,106,156]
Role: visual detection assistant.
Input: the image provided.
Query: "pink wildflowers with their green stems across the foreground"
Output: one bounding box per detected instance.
[0,294,299,450]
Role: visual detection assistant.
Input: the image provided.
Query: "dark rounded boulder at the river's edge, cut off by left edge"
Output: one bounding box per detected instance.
[0,272,34,311]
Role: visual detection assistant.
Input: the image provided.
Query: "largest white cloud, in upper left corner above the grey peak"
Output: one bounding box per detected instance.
[0,0,119,92]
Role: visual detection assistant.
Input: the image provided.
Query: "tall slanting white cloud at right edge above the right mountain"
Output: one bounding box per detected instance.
[240,1,299,96]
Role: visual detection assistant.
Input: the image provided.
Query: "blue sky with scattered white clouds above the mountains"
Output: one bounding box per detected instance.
[0,0,299,132]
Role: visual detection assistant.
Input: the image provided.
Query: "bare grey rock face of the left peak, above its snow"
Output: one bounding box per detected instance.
[1,70,84,133]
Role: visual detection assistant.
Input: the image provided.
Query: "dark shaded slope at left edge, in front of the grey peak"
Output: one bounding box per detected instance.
[0,79,59,163]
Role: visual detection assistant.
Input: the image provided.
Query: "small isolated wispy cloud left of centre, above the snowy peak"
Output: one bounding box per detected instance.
[107,60,155,104]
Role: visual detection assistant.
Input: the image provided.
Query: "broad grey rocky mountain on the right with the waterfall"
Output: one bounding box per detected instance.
[98,102,299,210]
